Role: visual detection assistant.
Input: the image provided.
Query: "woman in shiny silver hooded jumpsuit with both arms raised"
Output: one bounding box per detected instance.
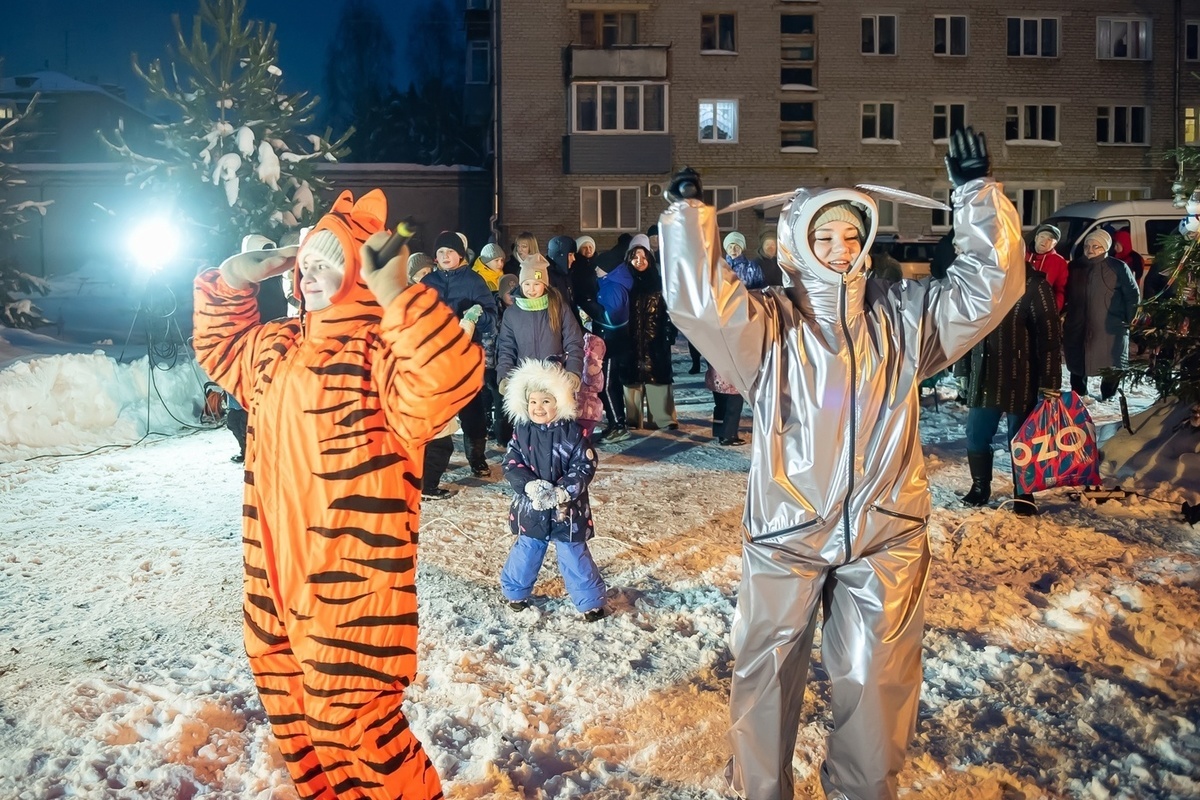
[659,128,1025,800]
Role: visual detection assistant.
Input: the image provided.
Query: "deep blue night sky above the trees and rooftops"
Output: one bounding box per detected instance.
[0,0,427,102]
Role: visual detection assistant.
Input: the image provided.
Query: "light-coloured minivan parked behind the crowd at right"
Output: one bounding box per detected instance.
[1043,200,1186,265]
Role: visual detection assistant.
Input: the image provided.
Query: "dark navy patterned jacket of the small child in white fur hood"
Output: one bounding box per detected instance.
[504,420,598,542]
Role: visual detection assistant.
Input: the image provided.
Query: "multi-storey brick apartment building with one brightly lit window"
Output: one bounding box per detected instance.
[484,0,1200,248]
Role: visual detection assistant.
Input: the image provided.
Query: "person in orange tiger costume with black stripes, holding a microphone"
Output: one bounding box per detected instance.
[194,190,484,800]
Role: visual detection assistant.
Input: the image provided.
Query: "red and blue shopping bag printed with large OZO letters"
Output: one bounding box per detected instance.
[1012,392,1100,494]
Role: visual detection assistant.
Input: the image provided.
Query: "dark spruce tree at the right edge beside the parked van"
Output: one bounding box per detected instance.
[1129,148,1200,405]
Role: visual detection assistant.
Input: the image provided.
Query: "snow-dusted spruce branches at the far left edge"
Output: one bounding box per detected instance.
[0,95,50,329]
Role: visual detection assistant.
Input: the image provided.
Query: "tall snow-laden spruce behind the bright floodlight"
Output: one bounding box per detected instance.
[104,0,353,263]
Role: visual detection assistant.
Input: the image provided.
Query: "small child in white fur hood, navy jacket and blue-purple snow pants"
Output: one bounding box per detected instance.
[500,359,608,622]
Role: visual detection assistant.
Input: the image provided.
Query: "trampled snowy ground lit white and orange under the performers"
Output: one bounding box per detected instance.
[0,275,1200,800]
